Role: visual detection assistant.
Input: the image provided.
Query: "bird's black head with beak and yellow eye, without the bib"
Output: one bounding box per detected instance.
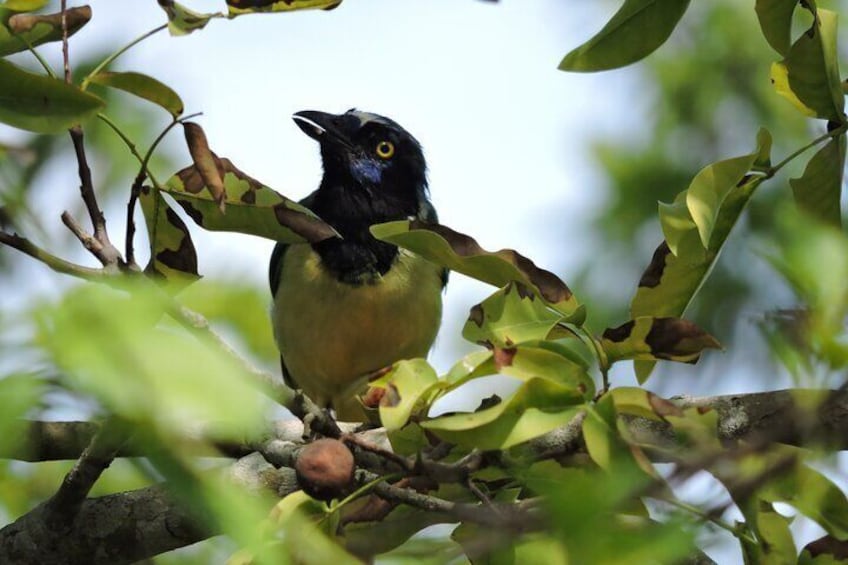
[293,110,427,228]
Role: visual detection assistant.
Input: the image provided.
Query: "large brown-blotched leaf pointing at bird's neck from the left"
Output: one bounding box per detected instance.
[163,153,338,243]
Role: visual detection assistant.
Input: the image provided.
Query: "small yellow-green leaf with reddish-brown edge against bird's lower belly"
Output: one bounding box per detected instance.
[378,359,441,430]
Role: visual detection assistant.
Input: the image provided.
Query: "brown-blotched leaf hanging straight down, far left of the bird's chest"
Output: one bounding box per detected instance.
[138,186,200,292]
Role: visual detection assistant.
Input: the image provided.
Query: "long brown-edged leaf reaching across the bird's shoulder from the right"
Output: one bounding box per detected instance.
[371,220,586,325]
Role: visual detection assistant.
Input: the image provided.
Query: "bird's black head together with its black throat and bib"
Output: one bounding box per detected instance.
[292,110,436,284]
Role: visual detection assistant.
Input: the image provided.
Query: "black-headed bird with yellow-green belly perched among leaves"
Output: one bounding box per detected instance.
[269,108,448,422]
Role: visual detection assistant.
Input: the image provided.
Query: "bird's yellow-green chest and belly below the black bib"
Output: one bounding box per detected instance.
[272,244,442,404]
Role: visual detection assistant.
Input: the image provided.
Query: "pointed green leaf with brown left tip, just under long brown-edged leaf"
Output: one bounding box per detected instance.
[462,282,563,348]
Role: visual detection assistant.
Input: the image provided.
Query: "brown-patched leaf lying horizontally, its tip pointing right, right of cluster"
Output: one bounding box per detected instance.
[601,316,721,363]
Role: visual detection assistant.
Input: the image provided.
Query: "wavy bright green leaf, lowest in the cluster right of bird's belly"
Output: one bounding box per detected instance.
[421,378,583,450]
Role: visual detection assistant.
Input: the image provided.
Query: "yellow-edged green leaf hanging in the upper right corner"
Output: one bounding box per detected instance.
[772,9,845,123]
